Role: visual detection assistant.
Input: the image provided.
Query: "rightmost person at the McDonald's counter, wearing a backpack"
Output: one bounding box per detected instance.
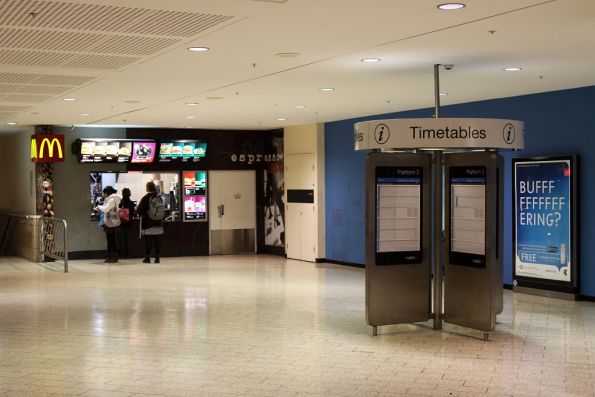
[136,181,165,263]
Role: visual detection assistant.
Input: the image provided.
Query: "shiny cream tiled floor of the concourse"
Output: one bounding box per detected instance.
[0,256,595,396]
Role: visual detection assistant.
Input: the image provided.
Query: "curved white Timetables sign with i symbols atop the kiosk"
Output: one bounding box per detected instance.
[354,118,524,150]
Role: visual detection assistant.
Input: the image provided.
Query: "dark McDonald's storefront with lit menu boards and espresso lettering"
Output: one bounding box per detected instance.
[53,127,285,259]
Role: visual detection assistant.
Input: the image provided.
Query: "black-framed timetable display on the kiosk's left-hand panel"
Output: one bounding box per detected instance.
[375,167,423,266]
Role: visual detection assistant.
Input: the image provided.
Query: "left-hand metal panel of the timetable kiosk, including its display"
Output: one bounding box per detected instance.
[366,153,431,329]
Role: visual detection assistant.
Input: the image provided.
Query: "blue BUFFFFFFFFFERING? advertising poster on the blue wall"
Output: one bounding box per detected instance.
[513,156,578,286]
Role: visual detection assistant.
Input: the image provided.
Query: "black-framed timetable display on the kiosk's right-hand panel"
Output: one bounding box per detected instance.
[449,167,486,267]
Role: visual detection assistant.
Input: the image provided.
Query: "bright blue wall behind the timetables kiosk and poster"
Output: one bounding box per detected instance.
[325,86,595,296]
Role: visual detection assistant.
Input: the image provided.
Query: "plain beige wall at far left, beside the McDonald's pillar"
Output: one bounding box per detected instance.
[0,128,36,215]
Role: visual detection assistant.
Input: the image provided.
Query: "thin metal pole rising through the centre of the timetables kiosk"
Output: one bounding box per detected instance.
[432,64,442,330]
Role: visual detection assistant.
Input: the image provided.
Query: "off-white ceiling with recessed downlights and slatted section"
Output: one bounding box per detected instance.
[0,0,595,130]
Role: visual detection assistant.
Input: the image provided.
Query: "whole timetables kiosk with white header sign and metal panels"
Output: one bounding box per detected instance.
[354,115,524,340]
